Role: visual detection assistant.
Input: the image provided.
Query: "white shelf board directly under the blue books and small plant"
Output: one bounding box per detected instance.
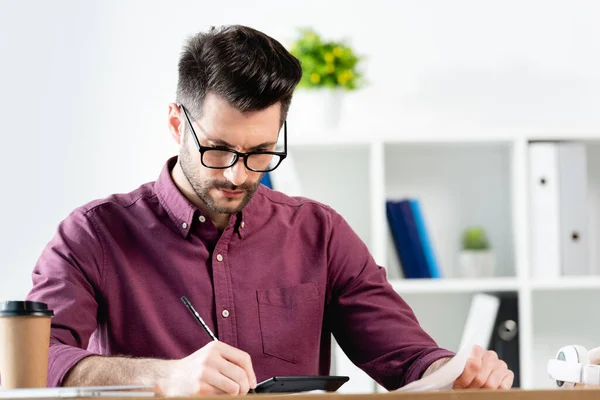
[390,278,520,294]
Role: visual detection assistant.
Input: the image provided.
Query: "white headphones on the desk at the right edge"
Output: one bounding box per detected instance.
[547,345,600,389]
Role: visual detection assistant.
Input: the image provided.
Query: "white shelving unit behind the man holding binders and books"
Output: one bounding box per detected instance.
[288,129,600,392]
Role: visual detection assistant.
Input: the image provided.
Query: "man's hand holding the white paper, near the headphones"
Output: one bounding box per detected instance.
[453,346,515,389]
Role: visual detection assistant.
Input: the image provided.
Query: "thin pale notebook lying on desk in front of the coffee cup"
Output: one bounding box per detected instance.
[0,385,154,399]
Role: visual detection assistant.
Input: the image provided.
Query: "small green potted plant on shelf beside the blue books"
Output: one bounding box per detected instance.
[459,226,496,278]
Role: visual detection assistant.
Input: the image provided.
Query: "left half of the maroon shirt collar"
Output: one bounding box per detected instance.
[154,156,197,238]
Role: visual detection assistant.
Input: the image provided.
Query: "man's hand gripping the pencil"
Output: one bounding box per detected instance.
[158,341,256,396]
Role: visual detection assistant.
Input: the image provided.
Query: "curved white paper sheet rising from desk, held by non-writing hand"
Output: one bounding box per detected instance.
[395,345,473,392]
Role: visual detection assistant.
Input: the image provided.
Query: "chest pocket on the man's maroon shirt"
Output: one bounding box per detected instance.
[256,282,323,363]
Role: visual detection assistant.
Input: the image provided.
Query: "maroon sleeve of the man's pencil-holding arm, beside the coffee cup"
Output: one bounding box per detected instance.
[27,210,103,387]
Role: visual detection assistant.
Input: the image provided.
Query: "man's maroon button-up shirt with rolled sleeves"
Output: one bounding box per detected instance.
[27,158,453,389]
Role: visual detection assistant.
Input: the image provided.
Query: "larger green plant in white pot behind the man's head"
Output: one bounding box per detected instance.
[290,28,364,129]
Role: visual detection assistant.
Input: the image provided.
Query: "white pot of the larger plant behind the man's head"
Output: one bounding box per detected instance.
[288,88,344,134]
